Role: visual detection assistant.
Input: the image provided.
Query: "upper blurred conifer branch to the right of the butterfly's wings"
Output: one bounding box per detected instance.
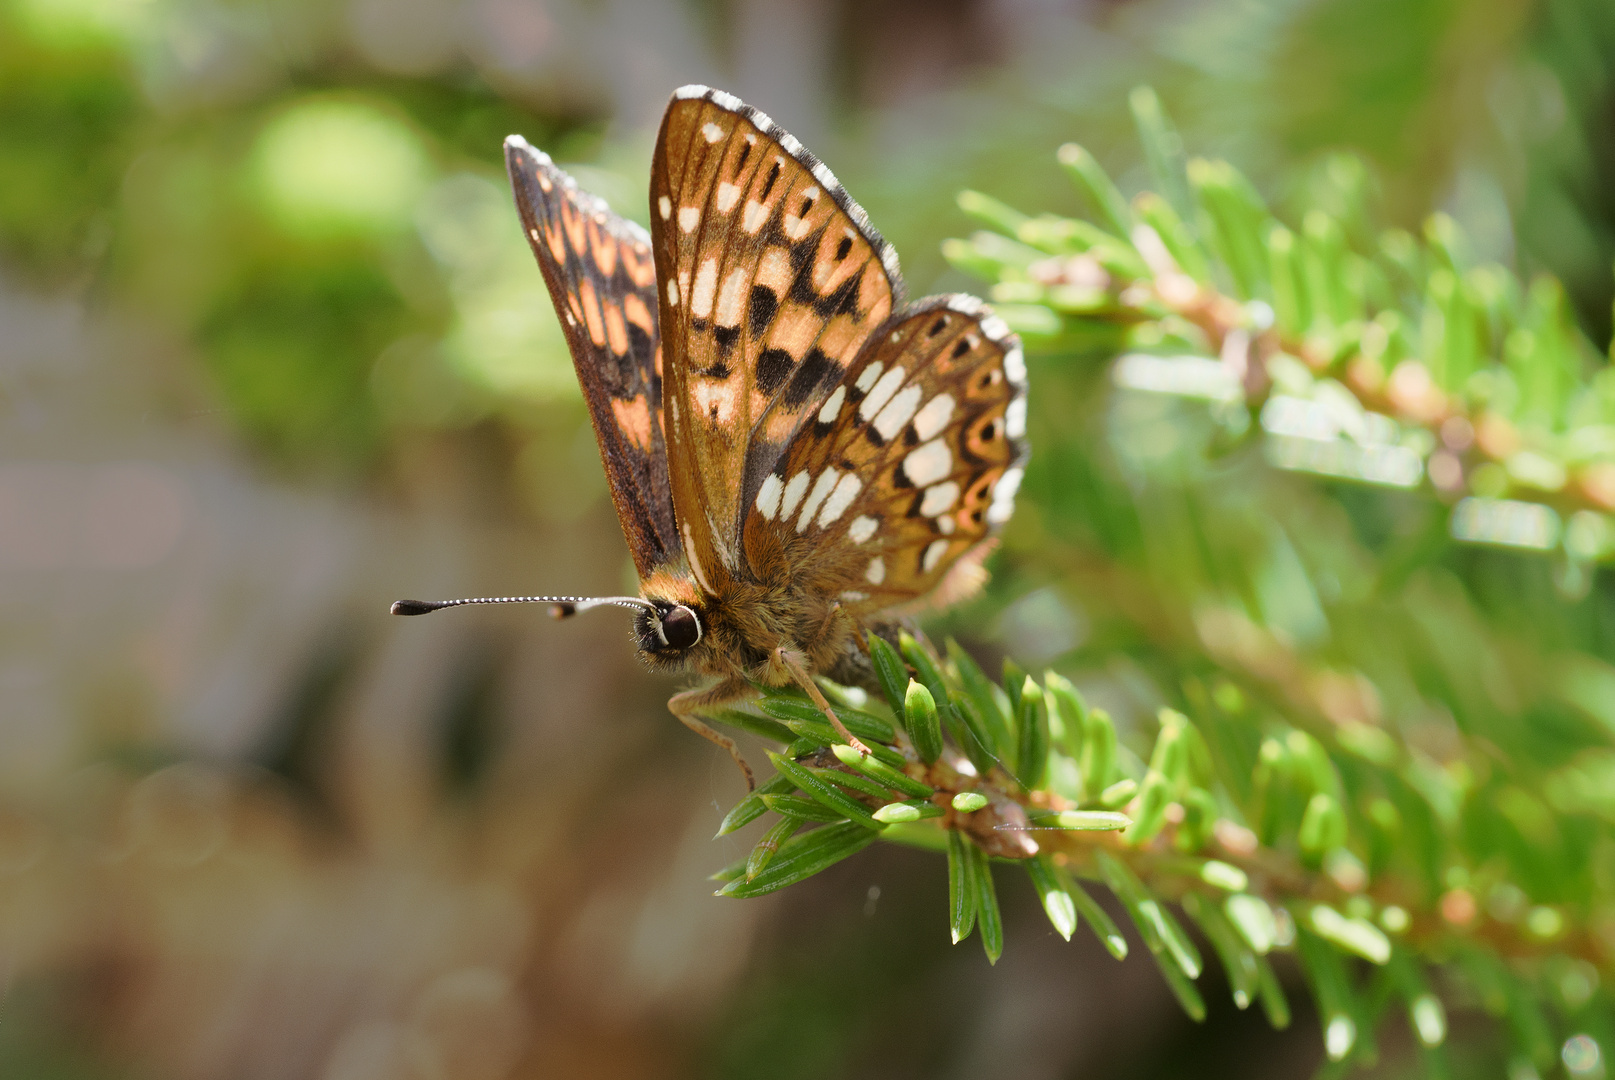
[943,89,1615,562]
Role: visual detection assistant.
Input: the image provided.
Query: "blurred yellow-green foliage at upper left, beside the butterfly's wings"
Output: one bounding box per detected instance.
[0,0,620,473]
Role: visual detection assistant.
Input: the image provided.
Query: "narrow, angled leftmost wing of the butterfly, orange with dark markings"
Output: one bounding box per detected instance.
[505,136,680,578]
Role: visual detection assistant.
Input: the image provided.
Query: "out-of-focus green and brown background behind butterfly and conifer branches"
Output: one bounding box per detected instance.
[0,0,1615,1080]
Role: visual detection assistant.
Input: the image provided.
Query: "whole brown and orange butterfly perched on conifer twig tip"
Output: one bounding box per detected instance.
[392,86,1027,785]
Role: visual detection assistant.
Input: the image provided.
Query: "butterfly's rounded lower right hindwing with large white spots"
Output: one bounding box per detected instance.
[745,295,1027,615]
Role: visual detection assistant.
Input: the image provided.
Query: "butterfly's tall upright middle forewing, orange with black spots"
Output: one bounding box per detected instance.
[651,86,901,594]
